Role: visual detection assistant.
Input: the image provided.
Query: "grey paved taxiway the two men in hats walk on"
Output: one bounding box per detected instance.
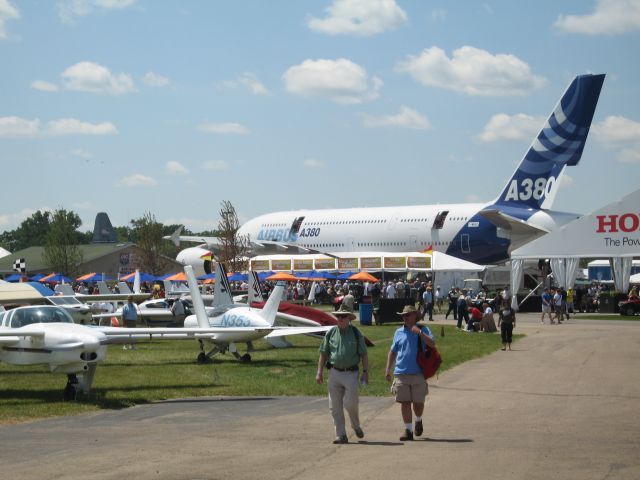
[0,314,640,480]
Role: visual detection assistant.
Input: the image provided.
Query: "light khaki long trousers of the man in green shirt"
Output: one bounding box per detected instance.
[328,368,360,437]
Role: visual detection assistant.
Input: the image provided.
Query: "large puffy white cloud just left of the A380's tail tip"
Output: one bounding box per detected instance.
[396,46,546,96]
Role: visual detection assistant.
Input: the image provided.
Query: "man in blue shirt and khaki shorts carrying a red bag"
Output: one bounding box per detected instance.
[385,305,436,441]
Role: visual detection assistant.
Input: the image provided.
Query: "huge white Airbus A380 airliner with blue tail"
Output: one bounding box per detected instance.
[172,74,605,269]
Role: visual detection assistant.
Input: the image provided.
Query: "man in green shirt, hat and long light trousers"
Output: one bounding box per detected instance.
[316,310,369,444]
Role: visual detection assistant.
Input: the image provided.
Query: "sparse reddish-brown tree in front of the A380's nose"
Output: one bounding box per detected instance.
[217,200,249,272]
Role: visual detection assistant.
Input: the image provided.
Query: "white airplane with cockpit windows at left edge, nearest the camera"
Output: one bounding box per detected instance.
[0,305,262,400]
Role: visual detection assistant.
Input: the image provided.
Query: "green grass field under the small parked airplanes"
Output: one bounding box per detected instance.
[0,324,519,423]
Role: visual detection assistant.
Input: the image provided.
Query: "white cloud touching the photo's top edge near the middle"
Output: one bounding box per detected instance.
[307,0,407,36]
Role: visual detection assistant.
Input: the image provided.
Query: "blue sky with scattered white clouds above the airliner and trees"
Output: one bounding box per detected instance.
[0,0,640,236]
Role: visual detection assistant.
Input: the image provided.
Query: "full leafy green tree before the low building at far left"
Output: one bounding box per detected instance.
[42,208,82,277]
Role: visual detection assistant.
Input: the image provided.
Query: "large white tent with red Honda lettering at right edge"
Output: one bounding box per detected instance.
[511,190,640,298]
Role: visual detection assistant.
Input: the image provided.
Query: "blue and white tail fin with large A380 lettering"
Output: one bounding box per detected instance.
[495,74,604,209]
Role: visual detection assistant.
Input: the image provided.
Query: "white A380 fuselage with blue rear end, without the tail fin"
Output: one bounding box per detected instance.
[238,203,578,264]
